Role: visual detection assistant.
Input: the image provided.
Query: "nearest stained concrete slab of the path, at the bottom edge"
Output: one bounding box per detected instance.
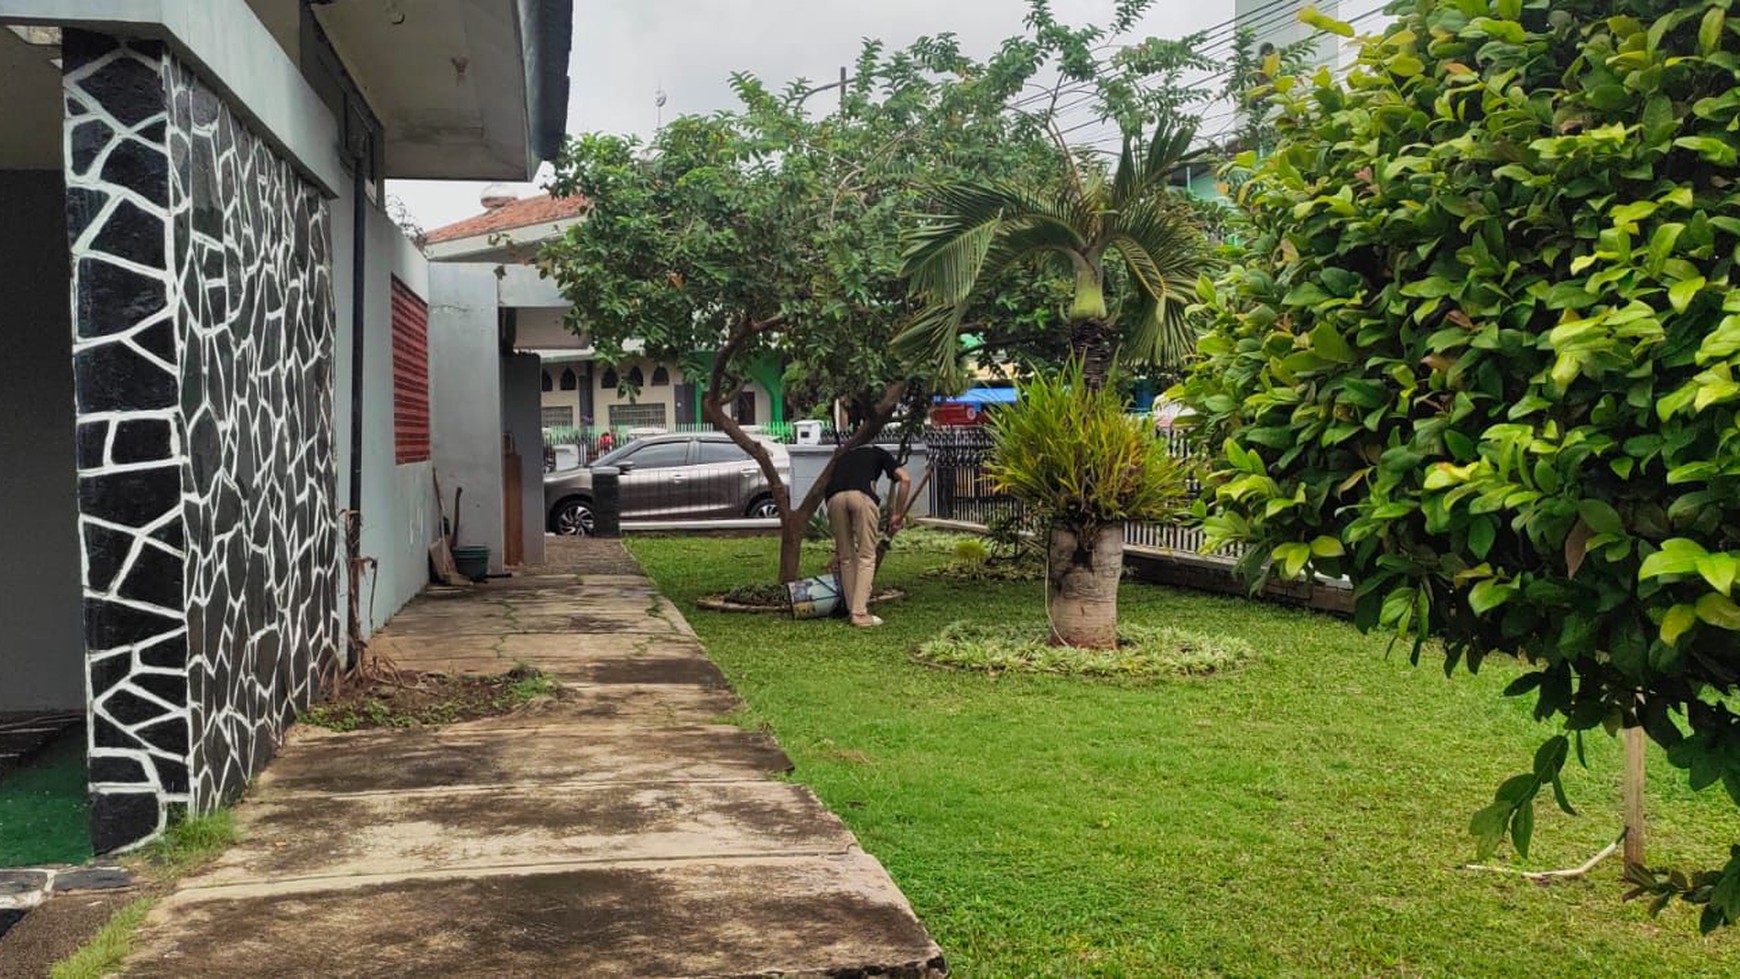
[125,850,947,979]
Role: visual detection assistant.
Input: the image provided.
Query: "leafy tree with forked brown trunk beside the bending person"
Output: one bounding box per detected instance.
[539,0,1224,581]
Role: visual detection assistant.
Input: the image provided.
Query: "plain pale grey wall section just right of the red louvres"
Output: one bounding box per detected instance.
[428,263,504,572]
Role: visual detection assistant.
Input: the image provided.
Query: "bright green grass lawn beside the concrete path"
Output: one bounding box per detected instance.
[632,537,1740,977]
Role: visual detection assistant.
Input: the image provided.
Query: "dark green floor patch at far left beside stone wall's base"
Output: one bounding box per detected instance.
[0,730,90,868]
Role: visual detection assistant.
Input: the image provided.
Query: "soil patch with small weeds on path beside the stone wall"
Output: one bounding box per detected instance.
[301,666,562,730]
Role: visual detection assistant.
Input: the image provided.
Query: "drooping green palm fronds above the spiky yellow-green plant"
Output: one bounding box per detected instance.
[896,125,1209,388]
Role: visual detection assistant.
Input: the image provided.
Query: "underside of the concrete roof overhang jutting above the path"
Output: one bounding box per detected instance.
[313,0,574,181]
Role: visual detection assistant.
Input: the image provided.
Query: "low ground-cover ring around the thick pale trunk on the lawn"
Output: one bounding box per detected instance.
[919,623,1255,678]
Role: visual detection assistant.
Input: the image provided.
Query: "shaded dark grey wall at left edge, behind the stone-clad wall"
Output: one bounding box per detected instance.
[0,170,85,713]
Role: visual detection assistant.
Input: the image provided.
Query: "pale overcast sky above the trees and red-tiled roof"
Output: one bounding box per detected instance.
[388,0,1376,228]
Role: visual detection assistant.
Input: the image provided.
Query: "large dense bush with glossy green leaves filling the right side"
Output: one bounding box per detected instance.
[1183,0,1740,929]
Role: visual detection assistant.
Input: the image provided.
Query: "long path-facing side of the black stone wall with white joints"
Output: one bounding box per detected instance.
[164,59,343,809]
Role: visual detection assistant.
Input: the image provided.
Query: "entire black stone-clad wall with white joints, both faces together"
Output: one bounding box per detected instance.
[63,31,341,850]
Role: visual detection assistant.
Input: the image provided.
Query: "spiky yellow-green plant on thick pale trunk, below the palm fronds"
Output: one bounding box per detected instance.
[988,360,1185,649]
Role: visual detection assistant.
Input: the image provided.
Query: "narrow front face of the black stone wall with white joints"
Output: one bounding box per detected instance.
[63,31,191,850]
